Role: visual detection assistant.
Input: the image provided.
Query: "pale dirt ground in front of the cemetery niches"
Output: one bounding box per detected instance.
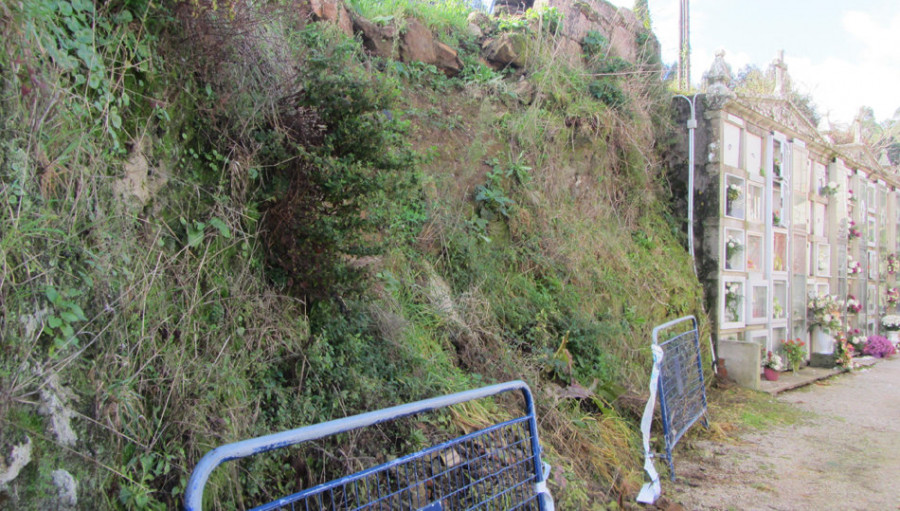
[663,357,900,511]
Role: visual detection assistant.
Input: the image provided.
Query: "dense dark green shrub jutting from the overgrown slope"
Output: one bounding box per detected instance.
[257,25,416,298]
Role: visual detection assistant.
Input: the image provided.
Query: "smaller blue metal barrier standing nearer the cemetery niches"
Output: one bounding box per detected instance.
[653,316,709,481]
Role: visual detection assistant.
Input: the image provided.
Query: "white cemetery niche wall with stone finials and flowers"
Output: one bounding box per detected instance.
[673,52,900,387]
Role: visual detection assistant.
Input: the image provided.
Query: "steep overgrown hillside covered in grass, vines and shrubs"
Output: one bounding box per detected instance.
[0,0,705,509]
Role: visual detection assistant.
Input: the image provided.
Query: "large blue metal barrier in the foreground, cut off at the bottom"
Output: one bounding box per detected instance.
[184,381,553,511]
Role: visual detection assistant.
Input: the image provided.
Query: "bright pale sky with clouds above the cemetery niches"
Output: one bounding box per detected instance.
[609,0,900,128]
